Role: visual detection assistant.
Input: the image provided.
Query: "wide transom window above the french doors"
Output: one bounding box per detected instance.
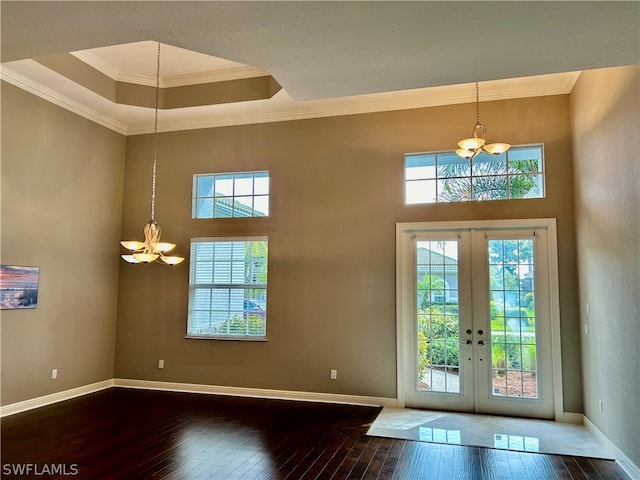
[405,145,545,204]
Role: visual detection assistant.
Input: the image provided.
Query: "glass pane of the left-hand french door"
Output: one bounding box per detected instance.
[416,240,460,394]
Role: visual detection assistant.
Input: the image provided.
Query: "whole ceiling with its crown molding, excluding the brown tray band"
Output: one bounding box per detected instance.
[0,1,640,134]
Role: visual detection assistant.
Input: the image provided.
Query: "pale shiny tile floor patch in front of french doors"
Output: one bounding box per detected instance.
[367,407,615,459]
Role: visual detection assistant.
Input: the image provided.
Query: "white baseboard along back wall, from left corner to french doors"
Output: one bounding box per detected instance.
[113,378,398,407]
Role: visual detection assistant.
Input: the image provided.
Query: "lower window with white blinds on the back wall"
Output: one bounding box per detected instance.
[187,237,268,340]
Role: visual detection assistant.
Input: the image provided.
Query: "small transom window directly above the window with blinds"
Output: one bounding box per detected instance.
[192,171,269,218]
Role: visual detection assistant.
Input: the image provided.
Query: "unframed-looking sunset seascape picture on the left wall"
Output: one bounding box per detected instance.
[0,265,40,310]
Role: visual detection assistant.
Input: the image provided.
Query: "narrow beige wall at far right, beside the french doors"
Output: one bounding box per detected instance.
[571,66,640,465]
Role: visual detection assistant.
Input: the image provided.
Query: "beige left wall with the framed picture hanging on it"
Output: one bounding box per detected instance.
[1,82,125,405]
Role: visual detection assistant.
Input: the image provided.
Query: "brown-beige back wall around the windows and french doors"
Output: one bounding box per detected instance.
[116,95,582,412]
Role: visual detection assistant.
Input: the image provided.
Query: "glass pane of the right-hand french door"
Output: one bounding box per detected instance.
[489,239,538,398]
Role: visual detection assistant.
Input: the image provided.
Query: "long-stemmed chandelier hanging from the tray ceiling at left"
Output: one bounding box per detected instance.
[120,42,184,265]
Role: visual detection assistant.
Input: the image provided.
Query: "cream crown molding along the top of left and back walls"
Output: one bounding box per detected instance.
[0,59,580,135]
